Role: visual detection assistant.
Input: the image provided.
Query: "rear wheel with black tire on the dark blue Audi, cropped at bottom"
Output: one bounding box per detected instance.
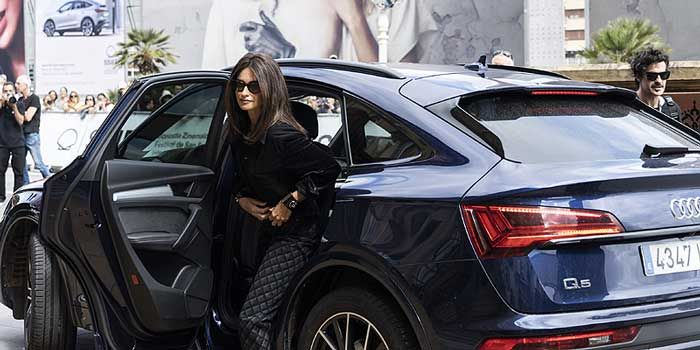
[297,288,419,350]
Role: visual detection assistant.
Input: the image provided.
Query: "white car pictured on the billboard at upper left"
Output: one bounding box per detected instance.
[44,0,110,36]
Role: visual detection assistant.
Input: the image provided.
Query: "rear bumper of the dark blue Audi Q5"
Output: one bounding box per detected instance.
[399,260,700,350]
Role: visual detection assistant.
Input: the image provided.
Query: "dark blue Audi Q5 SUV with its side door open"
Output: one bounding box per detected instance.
[0,60,700,350]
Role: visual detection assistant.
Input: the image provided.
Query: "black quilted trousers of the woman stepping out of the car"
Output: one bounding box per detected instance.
[239,224,318,350]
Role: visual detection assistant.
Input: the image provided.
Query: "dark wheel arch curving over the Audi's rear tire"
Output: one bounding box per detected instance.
[277,246,435,350]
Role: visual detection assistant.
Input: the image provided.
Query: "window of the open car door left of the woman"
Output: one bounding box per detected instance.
[118,83,223,165]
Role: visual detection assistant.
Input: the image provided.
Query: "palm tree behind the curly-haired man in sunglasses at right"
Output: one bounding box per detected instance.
[582,18,670,63]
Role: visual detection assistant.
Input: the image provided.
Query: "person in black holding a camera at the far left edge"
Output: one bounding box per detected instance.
[0,82,26,202]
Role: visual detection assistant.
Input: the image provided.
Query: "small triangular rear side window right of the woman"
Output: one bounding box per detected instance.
[346,93,421,164]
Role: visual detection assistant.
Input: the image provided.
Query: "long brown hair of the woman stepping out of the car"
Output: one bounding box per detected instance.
[225,53,306,143]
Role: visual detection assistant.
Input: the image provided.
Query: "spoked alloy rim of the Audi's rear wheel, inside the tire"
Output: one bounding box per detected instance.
[309,312,389,350]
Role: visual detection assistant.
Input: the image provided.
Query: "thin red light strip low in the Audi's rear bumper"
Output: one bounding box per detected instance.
[479,326,639,350]
